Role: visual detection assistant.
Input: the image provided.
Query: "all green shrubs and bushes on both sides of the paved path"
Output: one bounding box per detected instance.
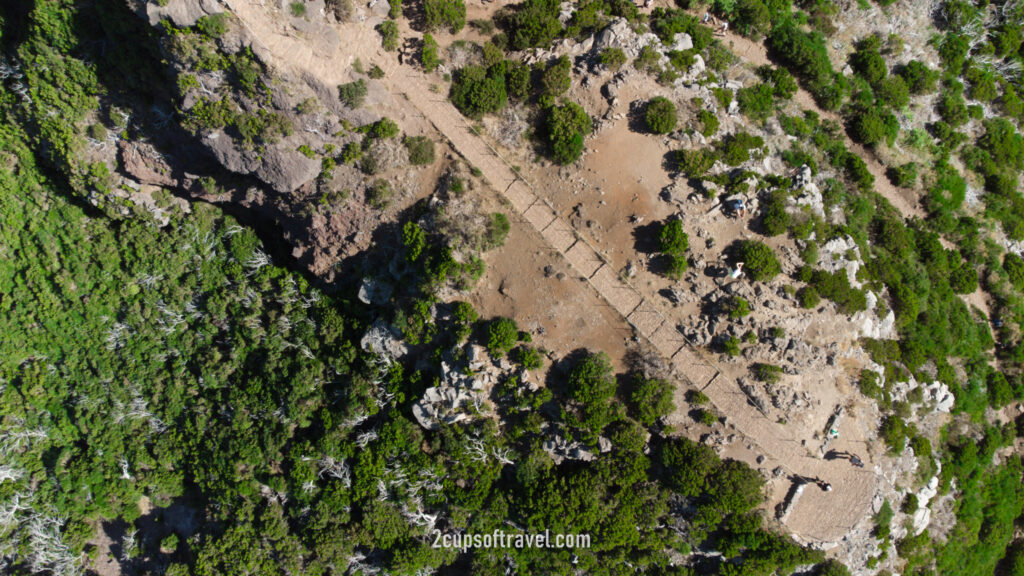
[6,0,1024,575]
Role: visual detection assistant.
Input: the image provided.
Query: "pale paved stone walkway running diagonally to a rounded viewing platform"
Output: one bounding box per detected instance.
[223,0,881,541]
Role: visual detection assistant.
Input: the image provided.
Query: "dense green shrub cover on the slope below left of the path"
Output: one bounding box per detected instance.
[0,0,860,575]
